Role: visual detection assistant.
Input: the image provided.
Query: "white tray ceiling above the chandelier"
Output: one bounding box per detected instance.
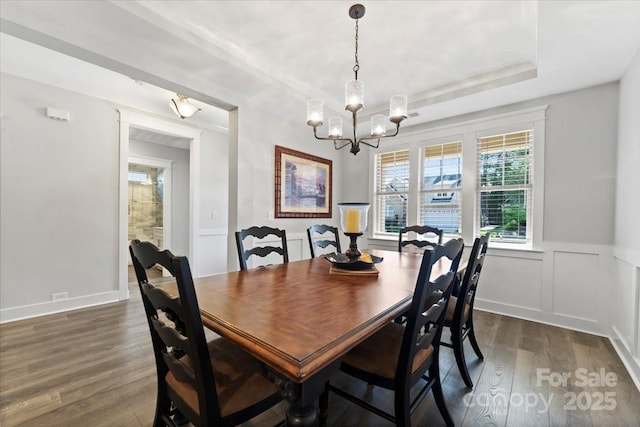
[0,0,640,130]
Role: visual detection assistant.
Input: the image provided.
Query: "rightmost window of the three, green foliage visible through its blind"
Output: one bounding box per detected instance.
[476,130,533,244]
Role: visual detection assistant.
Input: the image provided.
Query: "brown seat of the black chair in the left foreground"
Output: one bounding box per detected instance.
[165,338,278,417]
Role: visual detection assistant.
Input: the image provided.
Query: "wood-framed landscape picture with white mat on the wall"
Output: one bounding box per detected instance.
[275,145,333,218]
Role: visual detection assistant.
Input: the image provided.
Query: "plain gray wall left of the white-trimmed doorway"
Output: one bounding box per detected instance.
[0,74,118,308]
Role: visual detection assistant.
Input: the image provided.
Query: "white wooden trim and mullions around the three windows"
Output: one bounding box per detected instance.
[367,104,549,251]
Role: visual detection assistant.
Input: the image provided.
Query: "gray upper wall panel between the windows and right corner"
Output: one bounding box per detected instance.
[541,83,618,245]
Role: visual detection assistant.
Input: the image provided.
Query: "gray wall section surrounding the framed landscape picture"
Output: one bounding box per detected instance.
[229,98,348,270]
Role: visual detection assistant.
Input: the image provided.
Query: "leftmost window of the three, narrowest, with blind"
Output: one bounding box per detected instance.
[375,150,409,233]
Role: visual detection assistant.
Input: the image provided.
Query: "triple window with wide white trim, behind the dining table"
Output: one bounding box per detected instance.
[369,105,548,251]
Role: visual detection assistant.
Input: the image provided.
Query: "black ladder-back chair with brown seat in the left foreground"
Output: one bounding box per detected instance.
[129,240,282,427]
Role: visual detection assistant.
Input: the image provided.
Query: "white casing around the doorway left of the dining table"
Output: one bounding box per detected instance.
[118,109,202,300]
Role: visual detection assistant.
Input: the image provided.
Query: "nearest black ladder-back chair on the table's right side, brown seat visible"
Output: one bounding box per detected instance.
[320,239,464,427]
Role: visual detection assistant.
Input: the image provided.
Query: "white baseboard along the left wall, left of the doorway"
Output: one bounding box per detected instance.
[0,291,120,324]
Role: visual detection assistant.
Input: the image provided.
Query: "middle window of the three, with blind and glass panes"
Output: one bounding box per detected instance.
[418,141,462,235]
